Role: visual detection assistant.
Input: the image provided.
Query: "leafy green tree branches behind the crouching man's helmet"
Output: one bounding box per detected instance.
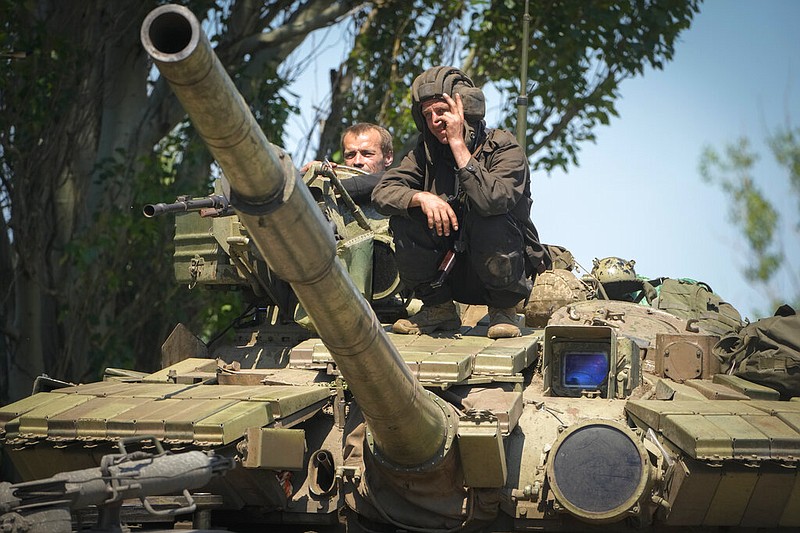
[317,0,699,170]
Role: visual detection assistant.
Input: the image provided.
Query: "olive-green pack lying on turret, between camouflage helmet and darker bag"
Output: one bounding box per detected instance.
[651,278,744,336]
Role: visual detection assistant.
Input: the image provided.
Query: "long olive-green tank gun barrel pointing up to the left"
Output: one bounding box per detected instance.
[141,5,453,467]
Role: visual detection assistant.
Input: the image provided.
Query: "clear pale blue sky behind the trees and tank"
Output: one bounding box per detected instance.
[287,0,800,318]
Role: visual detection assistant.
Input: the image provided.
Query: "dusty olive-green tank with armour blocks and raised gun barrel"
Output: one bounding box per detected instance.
[0,6,800,533]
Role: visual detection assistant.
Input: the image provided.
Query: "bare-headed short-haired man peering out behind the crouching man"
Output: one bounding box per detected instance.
[301,122,394,202]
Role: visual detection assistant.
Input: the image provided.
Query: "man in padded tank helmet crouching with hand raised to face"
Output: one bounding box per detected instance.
[372,66,550,338]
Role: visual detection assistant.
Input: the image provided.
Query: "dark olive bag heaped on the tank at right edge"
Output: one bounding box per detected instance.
[712,306,800,400]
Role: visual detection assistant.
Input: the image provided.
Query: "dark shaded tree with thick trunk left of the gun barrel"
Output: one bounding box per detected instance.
[0,0,354,398]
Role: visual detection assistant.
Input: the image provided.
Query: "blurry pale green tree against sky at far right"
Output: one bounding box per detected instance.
[700,126,800,309]
